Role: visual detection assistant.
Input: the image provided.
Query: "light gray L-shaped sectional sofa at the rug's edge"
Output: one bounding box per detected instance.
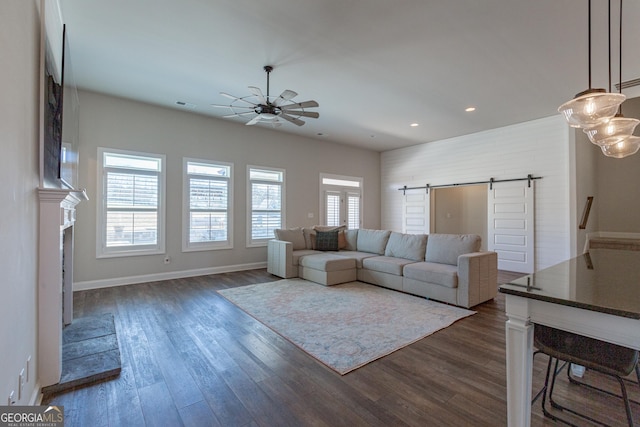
[267,226,498,308]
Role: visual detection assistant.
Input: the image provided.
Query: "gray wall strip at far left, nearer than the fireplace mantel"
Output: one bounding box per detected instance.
[0,0,40,405]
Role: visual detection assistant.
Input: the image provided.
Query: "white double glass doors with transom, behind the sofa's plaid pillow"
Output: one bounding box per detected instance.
[320,174,362,229]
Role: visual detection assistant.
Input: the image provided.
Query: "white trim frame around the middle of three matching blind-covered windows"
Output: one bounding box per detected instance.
[182,157,233,252]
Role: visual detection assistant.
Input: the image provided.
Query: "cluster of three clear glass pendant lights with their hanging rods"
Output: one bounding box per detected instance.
[558,0,640,158]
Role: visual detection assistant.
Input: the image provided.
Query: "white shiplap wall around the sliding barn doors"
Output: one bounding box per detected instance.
[381,116,575,271]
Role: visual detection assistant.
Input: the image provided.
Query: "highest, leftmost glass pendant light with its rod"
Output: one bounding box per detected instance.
[558,0,626,129]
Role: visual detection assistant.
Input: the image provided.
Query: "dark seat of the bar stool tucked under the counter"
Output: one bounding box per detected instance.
[534,324,638,377]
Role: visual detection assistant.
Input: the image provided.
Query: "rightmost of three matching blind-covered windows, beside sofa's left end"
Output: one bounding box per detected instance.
[247,166,285,246]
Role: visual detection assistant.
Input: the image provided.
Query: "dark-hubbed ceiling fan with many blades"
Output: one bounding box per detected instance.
[211,65,320,127]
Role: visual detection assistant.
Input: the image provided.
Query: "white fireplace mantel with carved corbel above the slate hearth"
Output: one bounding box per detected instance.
[38,188,87,386]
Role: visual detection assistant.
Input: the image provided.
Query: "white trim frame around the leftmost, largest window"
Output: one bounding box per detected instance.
[96,147,167,258]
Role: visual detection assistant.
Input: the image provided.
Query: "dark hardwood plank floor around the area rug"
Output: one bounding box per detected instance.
[43,270,640,427]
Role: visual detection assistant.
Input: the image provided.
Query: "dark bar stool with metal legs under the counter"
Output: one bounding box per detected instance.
[534,324,640,426]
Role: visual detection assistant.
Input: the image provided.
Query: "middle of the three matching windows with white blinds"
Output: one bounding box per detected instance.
[182,159,233,251]
